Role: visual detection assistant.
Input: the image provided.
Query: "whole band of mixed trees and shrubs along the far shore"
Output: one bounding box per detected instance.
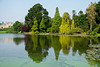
[0,1,100,35]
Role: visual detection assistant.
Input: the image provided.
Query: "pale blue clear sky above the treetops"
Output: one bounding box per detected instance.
[0,0,99,23]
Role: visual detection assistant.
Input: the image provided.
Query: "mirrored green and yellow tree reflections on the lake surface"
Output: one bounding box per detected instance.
[13,35,100,67]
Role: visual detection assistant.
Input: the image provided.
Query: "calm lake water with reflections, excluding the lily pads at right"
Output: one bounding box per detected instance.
[0,34,100,67]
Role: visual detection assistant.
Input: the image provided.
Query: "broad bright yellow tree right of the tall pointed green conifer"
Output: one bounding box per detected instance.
[60,12,70,34]
